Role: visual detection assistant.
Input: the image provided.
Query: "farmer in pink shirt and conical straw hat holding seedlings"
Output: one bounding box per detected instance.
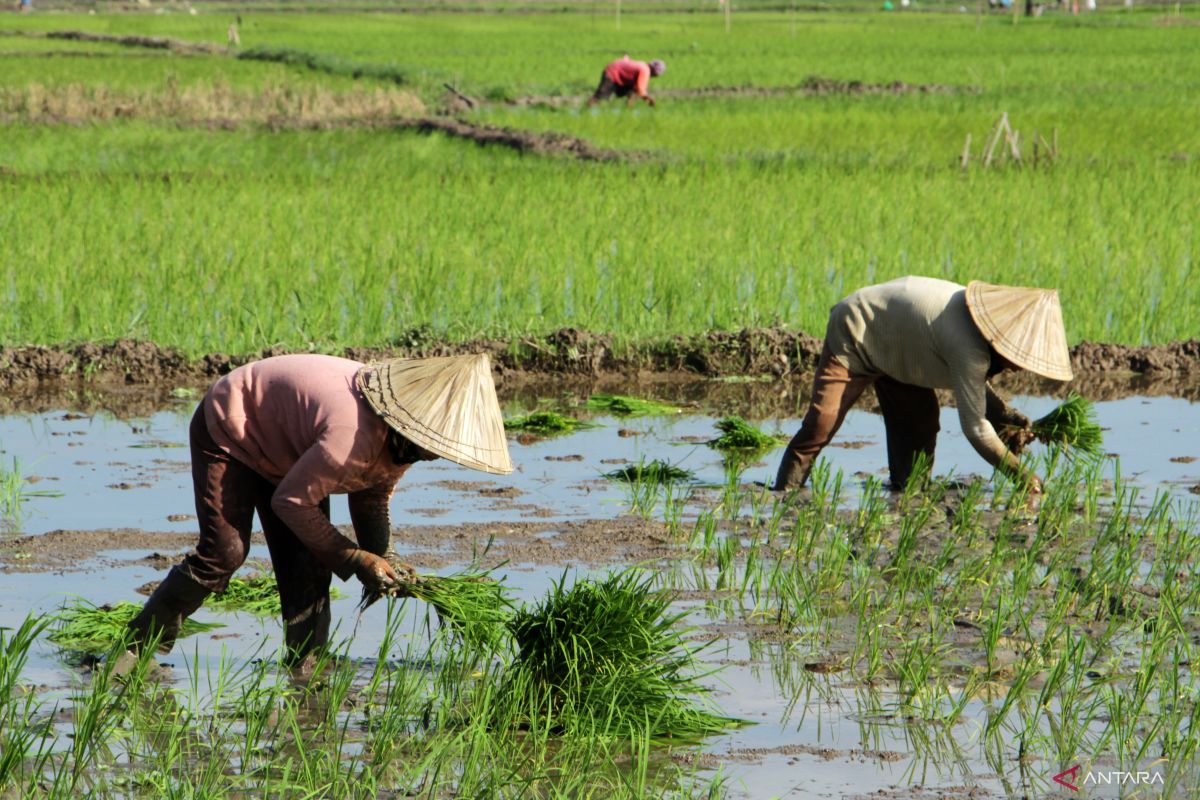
[114,355,512,672]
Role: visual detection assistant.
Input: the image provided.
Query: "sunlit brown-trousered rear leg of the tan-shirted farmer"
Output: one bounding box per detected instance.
[772,348,875,491]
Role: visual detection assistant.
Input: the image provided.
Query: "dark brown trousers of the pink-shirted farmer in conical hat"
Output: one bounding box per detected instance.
[182,403,332,657]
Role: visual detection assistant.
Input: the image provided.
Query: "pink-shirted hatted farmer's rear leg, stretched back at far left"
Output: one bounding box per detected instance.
[130,408,250,652]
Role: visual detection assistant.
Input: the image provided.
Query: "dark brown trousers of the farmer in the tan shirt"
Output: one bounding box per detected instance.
[774,348,941,489]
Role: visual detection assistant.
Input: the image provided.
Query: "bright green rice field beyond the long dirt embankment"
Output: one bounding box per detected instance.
[0,4,1200,355]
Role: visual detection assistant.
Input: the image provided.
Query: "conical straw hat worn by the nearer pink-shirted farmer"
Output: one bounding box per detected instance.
[355,354,512,475]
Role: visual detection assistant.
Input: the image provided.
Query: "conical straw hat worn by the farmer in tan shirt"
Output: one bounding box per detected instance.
[967,281,1074,380]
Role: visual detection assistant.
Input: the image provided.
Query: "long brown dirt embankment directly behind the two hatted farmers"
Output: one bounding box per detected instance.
[0,327,1200,399]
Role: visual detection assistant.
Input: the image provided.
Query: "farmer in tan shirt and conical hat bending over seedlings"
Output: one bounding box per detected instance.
[773,277,1072,493]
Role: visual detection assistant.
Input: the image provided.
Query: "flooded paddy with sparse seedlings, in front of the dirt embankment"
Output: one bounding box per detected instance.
[0,381,1200,798]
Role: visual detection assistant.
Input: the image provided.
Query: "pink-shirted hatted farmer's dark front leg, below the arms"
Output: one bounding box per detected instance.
[258,492,334,664]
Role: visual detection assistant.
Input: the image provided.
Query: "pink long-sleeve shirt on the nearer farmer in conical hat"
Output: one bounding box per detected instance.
[204,355,408,579]
